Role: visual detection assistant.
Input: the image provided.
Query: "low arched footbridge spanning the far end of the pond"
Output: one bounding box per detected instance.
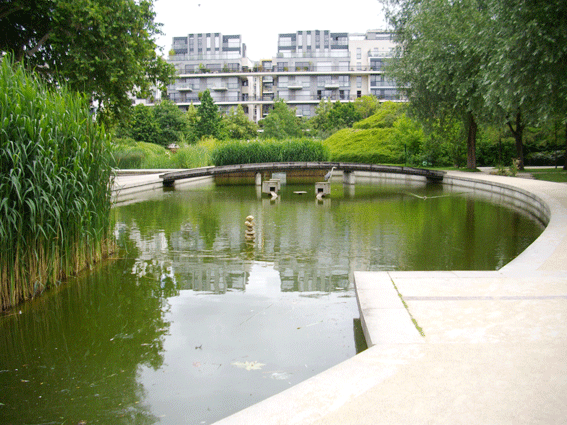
[160,162,445,186]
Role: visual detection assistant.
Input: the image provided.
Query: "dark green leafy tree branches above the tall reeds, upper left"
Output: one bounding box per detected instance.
[0,0,174,118]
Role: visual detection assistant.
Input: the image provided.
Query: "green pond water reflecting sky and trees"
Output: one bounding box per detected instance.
[0,184,543,424]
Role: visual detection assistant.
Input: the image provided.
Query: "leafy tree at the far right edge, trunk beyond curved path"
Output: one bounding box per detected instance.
[481,0,567,169]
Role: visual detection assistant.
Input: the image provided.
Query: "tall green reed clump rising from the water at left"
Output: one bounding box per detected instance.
[0,57,113,310]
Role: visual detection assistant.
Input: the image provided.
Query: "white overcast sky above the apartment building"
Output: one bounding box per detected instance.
[154,0,386,61]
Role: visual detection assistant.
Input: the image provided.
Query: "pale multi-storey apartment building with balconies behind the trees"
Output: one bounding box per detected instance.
[168,30,398,122]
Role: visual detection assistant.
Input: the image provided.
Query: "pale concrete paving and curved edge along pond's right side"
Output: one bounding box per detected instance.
[112,172,567,425]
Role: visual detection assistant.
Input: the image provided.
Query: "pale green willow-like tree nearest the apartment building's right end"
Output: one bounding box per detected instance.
[388,0,487,169]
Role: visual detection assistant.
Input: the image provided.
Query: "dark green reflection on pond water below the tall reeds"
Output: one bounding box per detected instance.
[0,262,171,424]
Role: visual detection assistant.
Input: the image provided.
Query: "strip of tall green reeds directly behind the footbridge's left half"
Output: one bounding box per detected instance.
[211,139,329,166]
